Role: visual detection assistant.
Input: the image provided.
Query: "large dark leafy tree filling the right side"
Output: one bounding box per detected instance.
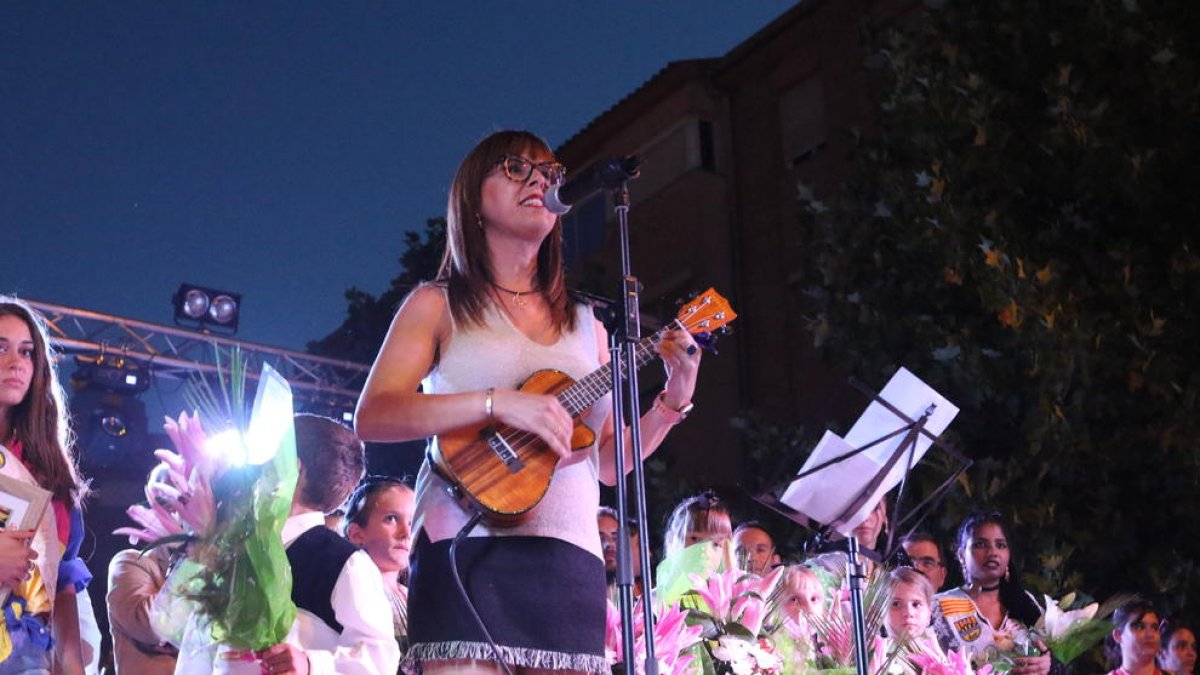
[802,0,1200,611]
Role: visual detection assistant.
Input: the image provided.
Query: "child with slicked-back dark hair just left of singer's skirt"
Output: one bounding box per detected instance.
[343,476,416,652]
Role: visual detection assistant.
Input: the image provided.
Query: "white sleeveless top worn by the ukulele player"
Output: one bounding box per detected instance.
[413,291,612,558]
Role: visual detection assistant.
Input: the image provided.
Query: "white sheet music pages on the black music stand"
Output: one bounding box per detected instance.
[780,368,959,537]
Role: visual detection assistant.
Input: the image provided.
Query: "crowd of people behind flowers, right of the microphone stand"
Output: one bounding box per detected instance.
[624,492,1196,675]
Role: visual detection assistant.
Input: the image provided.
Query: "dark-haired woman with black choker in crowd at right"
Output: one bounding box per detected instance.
[935,513,1061,675]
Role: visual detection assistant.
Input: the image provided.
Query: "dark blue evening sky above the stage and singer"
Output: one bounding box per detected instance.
[0,0,792,350]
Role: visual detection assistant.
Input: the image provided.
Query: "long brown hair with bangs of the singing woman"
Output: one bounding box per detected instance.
[438,131,575,333]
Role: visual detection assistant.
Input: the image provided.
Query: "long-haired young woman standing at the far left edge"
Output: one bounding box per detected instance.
[0,295,91,674]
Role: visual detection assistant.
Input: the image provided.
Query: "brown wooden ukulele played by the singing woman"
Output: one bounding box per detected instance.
[431,288,738,527]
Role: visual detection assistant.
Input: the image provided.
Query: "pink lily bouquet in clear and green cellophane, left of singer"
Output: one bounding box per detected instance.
[131,351,299,651]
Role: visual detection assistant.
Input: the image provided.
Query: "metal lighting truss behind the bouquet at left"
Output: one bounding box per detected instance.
[29,300,370,407]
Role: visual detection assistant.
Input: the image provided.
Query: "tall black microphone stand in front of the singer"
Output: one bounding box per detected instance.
[608,180,659,675]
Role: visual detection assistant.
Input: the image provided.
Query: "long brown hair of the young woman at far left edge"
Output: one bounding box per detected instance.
[0,295,88,506]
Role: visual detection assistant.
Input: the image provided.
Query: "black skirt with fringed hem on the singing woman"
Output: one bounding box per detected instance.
[404,531,610,673]
